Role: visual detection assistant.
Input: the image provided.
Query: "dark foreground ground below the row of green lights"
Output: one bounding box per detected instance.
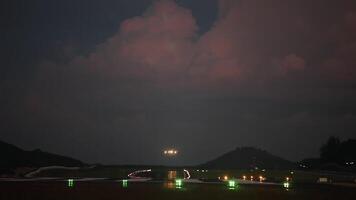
[0,182,356,200]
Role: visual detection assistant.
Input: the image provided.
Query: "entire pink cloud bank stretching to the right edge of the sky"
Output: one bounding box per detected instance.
[64,0,356,87]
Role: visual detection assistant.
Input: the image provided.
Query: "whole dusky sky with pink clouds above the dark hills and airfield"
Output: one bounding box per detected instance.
[0,0,356,164]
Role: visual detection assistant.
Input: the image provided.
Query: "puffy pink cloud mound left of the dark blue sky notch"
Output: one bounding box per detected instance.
[78,0,198,85]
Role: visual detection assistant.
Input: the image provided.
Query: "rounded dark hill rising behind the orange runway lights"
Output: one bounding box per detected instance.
[200,147,296,169]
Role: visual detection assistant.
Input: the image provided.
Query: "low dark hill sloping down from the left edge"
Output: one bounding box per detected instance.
[0,141,84,170]
